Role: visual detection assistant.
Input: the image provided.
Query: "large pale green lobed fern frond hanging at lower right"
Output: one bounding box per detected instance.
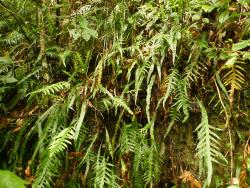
[195,100,226,185]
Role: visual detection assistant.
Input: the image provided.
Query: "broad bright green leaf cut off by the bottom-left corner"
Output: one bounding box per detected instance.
[0,170,28,188]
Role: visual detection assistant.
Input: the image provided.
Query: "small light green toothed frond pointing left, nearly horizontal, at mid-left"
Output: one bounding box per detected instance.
[28,81,70,95]
